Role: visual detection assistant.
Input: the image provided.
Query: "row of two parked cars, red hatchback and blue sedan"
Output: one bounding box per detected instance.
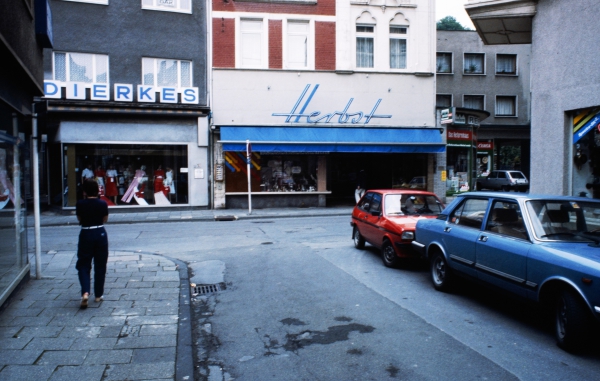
[351,190,600,350]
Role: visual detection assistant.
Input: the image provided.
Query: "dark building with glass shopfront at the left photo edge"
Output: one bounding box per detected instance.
[0,0,52,306]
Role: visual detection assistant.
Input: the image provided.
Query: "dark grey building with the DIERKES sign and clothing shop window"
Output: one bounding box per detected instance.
[40,0,210,210]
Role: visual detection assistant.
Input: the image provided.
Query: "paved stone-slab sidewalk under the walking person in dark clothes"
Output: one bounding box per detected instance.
[0,251,194,381]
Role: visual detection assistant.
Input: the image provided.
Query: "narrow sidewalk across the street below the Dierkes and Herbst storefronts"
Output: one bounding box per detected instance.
[32,206,352,227]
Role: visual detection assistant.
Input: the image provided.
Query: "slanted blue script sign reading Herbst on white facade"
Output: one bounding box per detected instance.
[272,84,392,124]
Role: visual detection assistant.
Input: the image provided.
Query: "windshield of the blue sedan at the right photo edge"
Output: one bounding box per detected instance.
[527,200,600,242]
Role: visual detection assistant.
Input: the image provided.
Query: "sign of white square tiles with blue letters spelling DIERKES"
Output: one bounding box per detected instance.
[44,80,200,104]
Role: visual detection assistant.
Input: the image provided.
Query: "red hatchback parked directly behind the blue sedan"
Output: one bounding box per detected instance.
[350,189,444,267]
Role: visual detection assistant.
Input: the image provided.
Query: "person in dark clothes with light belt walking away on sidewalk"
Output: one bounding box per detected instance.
[75,180,108,308]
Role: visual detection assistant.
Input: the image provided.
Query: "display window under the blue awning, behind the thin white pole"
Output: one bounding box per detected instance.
[225,152,318,192]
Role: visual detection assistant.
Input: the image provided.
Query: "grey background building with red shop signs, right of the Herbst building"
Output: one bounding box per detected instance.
[436,30,531,191]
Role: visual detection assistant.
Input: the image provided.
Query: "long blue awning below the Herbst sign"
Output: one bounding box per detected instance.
[219,126,446,153]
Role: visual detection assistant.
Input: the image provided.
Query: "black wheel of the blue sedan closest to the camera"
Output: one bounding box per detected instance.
[555,290,590,351]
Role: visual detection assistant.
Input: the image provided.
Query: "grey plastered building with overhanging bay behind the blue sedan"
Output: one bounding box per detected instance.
[465,0,600,198]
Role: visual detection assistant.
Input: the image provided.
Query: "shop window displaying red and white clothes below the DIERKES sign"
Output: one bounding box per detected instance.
[62,144,188,207]
